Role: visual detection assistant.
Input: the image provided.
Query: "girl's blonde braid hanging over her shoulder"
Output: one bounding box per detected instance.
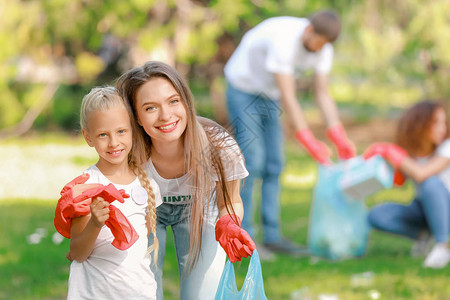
[130,160,159,266]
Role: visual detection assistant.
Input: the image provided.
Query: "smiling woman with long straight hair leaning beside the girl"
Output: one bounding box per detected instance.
[116,62,255,300]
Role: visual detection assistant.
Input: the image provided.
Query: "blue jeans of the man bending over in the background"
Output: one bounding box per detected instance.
[227,83,284,243]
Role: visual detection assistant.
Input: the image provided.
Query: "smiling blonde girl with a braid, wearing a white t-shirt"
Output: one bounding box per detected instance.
[62,87,161,299]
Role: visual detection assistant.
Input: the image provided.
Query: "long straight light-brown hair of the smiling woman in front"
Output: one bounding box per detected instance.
[116,61,241,272]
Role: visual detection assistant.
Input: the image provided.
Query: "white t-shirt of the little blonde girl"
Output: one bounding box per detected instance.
[67,165,161,300]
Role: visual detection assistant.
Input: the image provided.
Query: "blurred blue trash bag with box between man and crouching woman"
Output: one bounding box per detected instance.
[308,156,393,260]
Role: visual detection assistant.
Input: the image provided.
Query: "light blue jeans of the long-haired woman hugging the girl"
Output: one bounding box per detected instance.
[149,203,226,300]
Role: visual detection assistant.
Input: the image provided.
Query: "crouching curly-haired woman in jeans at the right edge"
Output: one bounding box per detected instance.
[364,100,450,268]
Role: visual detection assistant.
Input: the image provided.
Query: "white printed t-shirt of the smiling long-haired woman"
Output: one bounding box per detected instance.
[145,134,248,218]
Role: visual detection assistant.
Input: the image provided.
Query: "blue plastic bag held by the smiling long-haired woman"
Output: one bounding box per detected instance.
[214,249,267,300]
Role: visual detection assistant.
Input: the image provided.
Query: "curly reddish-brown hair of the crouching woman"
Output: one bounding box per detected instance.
[396,100,448,156]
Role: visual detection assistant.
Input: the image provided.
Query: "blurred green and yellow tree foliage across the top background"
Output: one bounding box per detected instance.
[0,0,450,137]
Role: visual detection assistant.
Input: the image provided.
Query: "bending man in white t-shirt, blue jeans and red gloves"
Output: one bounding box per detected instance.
[224,11,355,254]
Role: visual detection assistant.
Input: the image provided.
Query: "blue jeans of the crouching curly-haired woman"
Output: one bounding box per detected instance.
[369,176,450,243]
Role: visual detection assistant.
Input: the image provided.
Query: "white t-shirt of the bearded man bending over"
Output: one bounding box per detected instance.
[224,16,334,100]
